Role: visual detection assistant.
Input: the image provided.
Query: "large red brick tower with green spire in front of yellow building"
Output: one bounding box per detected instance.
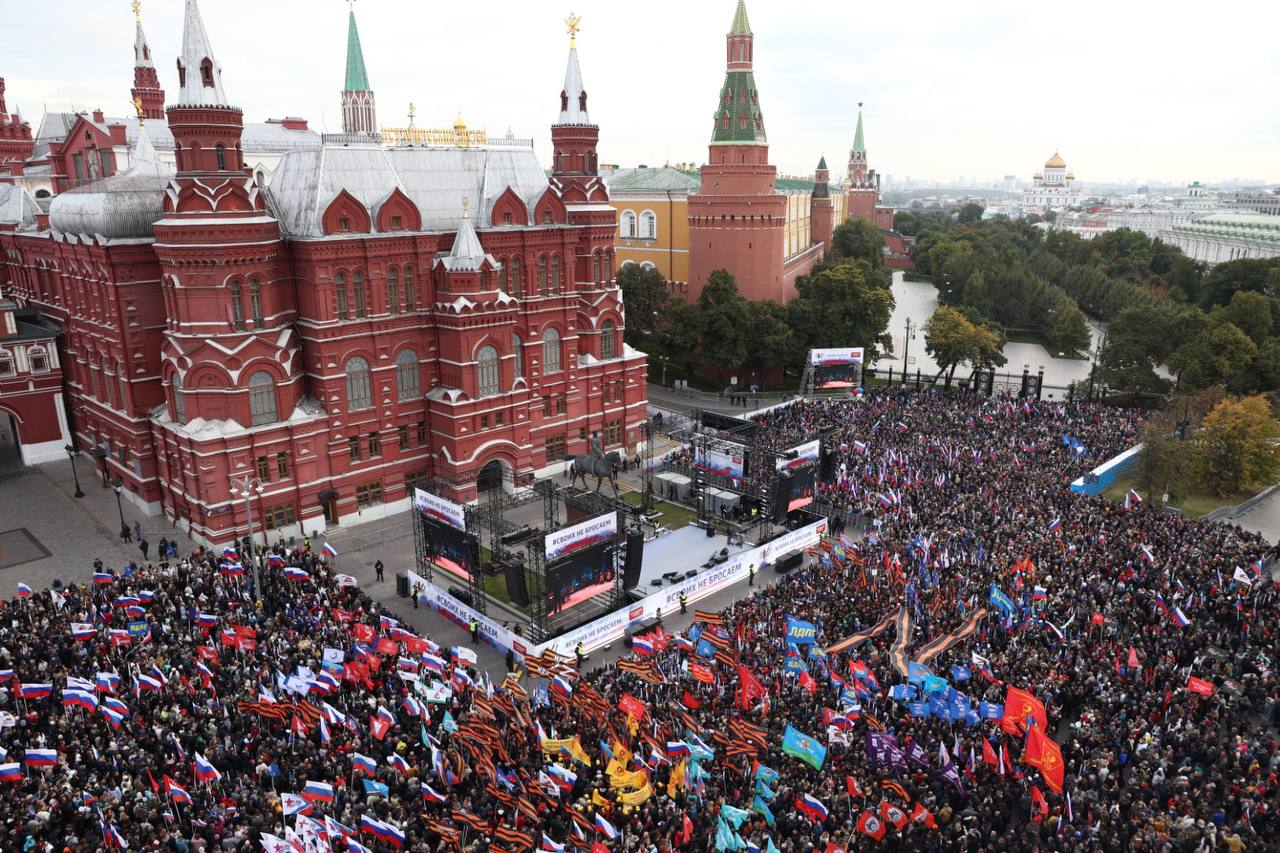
[689,0,795,302]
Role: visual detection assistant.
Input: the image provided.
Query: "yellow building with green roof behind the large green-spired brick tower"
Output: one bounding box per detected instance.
[604,167,845,282]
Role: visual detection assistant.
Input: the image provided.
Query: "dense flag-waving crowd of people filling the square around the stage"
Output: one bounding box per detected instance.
[0,389,1280,853]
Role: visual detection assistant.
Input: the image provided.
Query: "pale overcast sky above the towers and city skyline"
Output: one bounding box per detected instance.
[0,0,1280,182]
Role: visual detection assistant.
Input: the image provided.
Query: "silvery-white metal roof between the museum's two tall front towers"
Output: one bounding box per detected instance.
[270,143,548,237]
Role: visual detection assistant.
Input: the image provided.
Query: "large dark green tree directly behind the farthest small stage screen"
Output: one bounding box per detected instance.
[787,259,893,362]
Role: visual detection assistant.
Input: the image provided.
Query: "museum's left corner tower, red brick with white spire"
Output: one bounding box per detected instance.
[155,0,303,537]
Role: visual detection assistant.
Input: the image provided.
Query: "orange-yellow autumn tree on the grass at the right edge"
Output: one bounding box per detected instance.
[1196,396,1280,497]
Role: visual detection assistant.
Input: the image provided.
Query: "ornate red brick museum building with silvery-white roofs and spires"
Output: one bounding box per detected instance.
[0,0,646,543]
